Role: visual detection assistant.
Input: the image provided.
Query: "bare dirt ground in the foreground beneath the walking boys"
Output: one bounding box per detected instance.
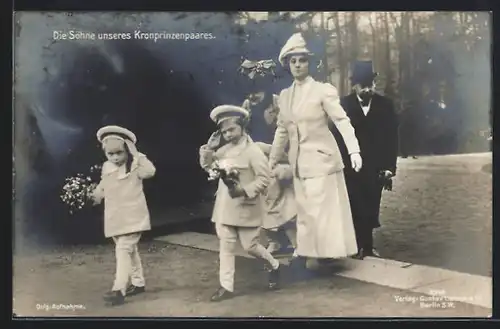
[14,242,489,317]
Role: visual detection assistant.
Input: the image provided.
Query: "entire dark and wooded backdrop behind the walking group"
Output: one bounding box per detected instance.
[13,12,492,243]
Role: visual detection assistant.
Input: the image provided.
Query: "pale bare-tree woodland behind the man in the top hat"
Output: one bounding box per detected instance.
[239,12,492,153]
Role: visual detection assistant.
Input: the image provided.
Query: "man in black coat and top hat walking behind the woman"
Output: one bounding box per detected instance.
[332,61,398,259]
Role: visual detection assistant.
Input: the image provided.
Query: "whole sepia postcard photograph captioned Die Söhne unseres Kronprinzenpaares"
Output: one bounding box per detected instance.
[12,11,493,319]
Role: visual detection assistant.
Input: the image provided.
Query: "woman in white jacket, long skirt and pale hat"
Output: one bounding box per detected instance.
[270,33,362,259]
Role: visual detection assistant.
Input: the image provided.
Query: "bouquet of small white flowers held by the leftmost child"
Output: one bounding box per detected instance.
[60,165,100,214]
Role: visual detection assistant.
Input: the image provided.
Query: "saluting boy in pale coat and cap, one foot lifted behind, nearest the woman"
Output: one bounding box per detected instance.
[200,105,280,301]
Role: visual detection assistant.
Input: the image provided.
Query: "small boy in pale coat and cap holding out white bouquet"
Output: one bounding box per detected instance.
[92,126,156,305]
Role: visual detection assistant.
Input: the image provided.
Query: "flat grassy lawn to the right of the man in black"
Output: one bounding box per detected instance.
[375,153,493,276]
